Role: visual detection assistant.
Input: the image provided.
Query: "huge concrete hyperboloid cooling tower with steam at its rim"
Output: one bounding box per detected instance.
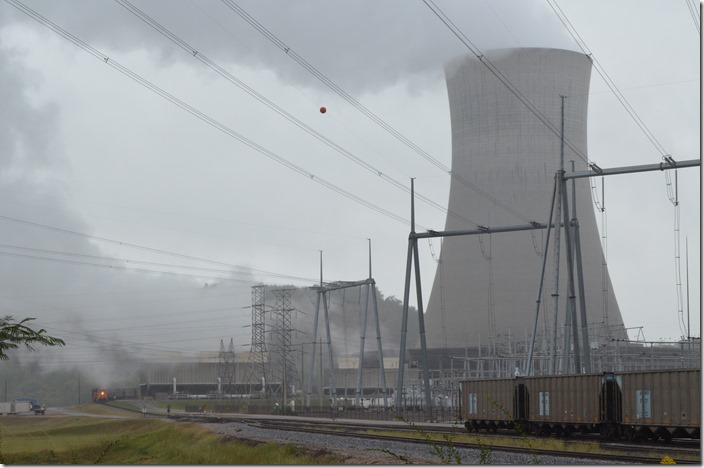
[425,49,625,348]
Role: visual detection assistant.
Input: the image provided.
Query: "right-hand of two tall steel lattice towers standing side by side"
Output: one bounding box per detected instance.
[272,289,301,407]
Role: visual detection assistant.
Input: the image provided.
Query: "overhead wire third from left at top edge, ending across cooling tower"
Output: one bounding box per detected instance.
[222,0,532,225]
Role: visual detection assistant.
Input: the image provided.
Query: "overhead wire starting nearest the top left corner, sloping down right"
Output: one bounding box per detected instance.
[5,0,426,229]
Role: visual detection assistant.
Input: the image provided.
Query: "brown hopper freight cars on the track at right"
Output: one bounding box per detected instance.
[460,369,701,442]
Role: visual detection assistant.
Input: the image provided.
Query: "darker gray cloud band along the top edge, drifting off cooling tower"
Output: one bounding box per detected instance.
[5,0,574,94]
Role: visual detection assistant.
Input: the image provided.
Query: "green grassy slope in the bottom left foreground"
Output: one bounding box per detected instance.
[0,416,340,465]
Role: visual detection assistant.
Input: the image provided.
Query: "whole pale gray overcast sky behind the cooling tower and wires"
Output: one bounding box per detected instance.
[0,0,701,372]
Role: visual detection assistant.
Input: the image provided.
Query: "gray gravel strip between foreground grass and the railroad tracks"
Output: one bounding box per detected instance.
[203,422,614,465]
